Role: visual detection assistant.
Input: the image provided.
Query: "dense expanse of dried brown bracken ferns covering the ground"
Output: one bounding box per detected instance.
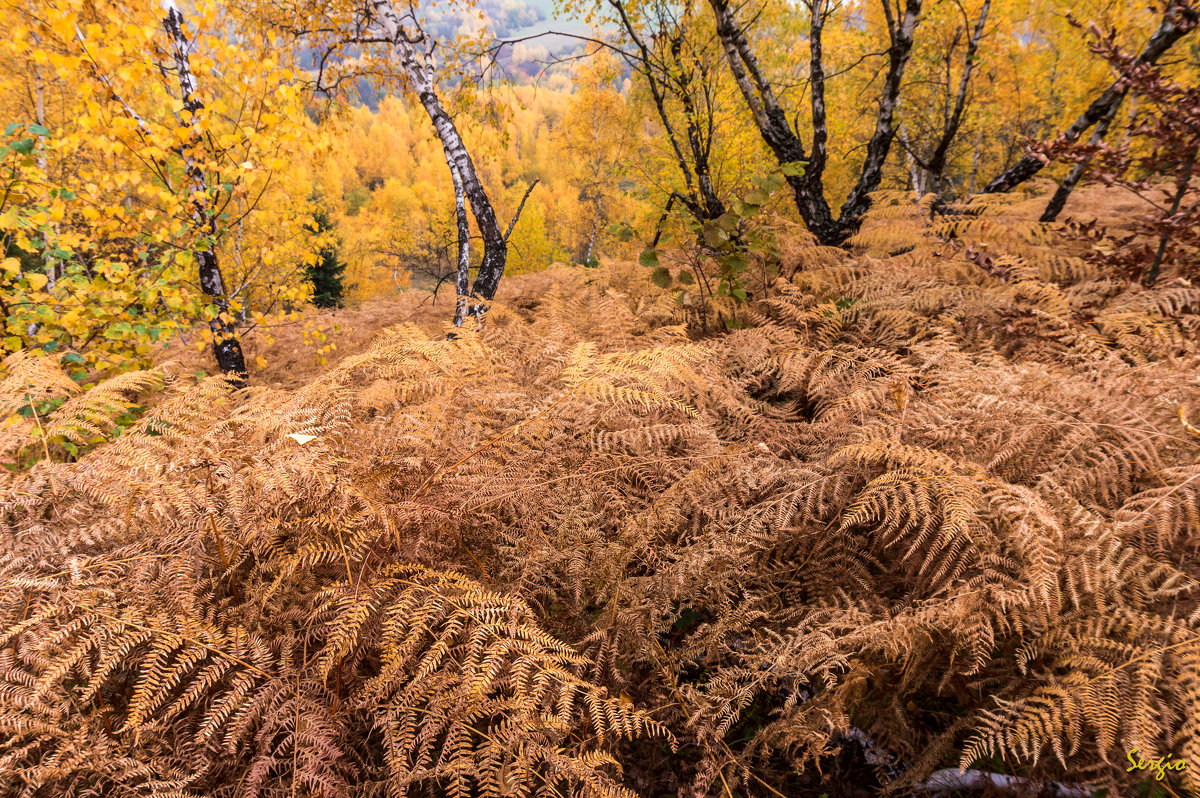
[0,189,1200,797]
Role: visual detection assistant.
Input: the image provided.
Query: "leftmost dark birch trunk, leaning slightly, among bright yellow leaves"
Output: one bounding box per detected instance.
[162,0,247,383]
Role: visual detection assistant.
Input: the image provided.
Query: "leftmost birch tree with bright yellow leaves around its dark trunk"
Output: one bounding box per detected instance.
[0,0,319,378]
